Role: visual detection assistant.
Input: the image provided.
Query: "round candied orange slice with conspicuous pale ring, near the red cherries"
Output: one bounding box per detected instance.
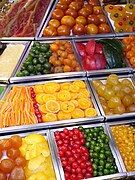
[46,100,60,113]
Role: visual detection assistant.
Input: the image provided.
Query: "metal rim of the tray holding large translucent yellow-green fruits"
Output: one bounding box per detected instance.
[88,74,135,121]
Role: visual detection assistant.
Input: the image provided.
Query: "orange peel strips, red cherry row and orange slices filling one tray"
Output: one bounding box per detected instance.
[0,79,97,128]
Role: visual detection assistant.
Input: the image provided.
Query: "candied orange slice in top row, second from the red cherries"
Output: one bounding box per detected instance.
[43,82,59,94]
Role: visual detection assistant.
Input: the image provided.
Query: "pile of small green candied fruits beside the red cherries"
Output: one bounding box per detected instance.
[78,126,118,177]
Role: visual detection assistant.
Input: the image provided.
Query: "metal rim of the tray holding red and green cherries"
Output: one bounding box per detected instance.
[50,123,126,180]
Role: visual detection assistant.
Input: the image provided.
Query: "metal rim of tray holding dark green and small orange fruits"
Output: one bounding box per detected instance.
[9,40,86,83]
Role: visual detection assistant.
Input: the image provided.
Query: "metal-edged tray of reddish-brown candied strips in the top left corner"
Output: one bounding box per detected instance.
[0,0,54,41]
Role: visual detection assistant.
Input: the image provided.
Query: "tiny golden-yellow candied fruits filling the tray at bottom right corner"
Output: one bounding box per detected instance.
[111,125,135,172]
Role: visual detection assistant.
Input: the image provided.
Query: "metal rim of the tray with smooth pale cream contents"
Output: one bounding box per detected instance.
[0,41,29,84]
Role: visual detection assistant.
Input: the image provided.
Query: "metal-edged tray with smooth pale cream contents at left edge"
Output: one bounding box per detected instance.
[0,41,29,83]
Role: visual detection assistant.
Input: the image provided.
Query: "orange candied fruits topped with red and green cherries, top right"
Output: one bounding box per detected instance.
[105,3,135,33]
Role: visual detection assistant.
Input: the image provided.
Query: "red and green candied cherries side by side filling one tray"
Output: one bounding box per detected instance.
[54,126,118,180]
